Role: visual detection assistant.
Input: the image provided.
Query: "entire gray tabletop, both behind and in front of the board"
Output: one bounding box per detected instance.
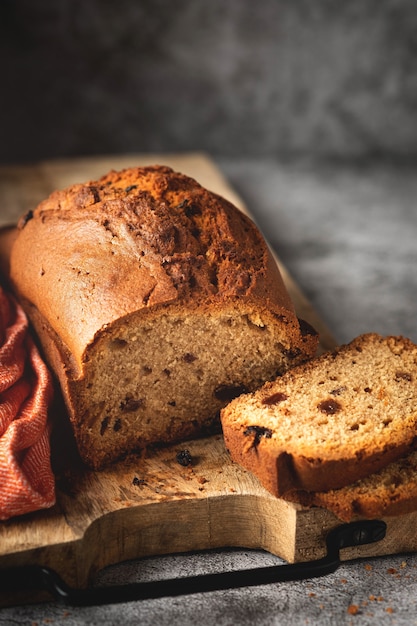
[0,159,417,626]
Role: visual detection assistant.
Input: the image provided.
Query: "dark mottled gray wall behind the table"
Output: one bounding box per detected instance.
[0,0,417,163]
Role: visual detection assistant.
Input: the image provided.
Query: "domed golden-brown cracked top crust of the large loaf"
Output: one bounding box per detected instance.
[10,166,308,376]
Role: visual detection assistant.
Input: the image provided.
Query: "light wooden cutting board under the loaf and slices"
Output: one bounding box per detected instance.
[0,154,417,604]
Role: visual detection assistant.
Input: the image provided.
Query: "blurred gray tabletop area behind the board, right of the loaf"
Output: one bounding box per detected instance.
[219,159,417,342]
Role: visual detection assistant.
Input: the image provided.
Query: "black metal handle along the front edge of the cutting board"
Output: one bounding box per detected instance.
[0,520,386,606]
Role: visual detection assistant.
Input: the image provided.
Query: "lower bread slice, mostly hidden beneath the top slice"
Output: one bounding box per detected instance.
[286,451,417,522]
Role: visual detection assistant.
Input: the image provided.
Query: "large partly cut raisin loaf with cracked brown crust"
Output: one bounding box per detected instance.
[10,166,318,468]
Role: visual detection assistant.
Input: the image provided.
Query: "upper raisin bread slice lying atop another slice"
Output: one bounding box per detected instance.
[221,333,417,496]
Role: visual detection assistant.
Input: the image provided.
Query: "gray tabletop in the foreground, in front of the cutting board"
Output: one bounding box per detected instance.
[0,552,417,626]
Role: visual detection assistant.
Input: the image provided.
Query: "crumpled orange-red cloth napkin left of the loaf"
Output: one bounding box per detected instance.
[0,287,55,520]
